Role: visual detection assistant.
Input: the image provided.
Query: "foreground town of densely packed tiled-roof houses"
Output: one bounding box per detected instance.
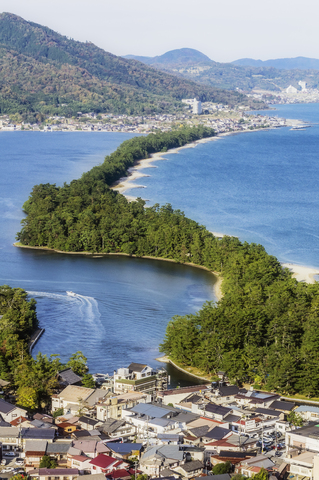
[0,363,319,480]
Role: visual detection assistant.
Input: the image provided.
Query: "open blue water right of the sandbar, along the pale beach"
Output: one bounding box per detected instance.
[126,104,319,267]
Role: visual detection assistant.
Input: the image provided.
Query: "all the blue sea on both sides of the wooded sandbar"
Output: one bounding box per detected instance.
[0,104,319,386]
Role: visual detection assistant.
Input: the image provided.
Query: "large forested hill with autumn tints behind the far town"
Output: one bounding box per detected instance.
[0,13,264,116]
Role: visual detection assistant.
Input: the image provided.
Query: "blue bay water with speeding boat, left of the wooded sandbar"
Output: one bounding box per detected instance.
[0,132,215,383]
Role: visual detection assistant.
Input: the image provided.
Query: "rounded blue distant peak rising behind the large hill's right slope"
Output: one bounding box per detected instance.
[124,48,215,65]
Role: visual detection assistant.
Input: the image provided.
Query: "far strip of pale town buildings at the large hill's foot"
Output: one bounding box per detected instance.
[0,99,289,134]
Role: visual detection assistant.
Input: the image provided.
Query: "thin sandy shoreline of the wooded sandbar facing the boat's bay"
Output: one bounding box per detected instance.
[13,242,223,302]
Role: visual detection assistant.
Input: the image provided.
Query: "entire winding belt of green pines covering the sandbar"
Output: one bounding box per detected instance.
[18,127,319,395]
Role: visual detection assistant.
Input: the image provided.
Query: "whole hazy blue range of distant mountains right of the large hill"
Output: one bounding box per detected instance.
[125,48,319,93]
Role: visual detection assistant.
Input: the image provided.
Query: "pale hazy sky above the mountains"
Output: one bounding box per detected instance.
[0,0,319,62]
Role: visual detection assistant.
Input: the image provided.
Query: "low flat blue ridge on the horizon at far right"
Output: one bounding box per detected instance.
[232,57,319,70]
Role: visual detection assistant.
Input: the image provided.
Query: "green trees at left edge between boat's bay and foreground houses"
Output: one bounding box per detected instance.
[0,285,94,410]
